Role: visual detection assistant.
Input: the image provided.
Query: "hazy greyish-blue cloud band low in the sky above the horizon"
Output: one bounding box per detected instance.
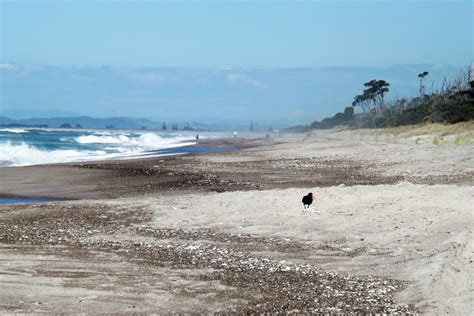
[0,63,462,124]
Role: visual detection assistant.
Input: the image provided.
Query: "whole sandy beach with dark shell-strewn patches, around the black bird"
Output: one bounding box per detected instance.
[0,126,474,315]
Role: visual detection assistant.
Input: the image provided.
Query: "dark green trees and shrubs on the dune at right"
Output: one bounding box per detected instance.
[287,66,474,132]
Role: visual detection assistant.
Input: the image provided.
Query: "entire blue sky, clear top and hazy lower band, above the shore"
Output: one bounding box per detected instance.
[0,0,474,123]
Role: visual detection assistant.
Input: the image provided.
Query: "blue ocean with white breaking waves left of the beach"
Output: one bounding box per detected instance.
[0,128,206,167]
